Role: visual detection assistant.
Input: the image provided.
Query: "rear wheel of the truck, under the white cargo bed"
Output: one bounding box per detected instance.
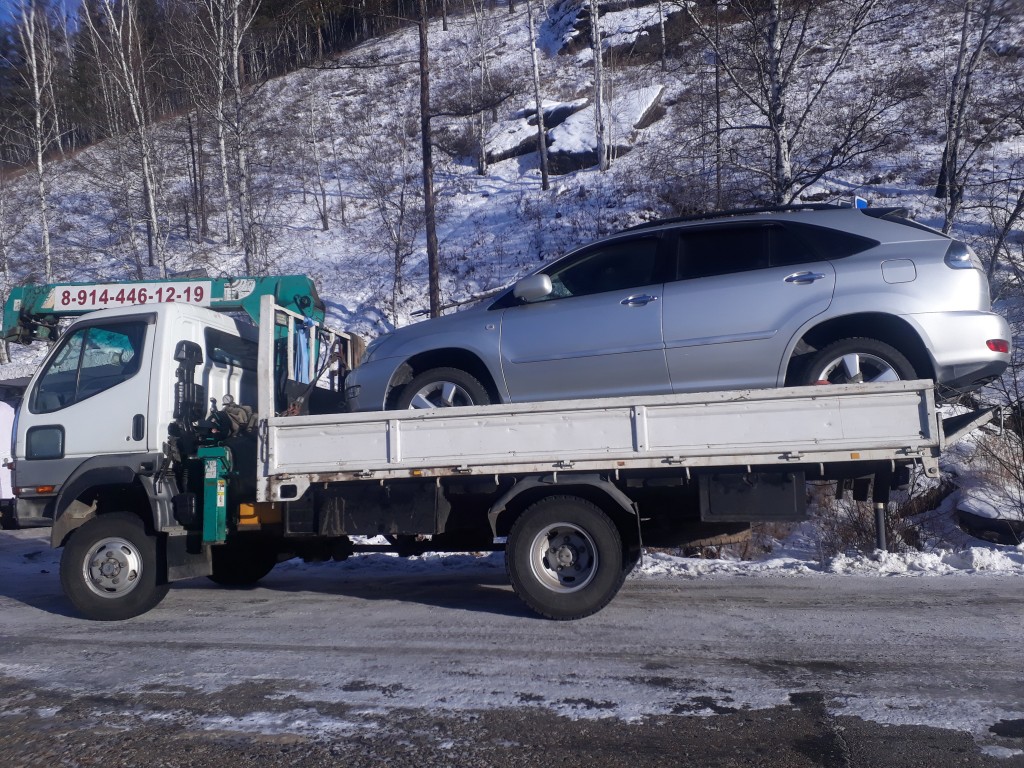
[505,496,628,621]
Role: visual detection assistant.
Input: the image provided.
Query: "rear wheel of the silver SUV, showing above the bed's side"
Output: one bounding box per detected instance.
[800,337,918,384]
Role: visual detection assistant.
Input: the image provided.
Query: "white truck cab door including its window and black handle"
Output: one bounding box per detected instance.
[15,314,156,486]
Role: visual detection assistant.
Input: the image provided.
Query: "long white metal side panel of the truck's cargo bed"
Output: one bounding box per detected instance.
[260,381,944,501]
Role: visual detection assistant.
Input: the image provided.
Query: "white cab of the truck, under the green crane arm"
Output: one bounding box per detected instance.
[13,303,256,525]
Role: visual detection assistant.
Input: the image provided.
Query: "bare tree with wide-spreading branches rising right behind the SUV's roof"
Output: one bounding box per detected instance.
[683,0,907,204]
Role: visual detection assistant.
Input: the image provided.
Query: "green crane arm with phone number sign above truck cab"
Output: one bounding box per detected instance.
[0,274,325,344]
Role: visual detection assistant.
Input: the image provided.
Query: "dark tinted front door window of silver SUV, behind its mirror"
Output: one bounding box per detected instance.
[548,238,662,300]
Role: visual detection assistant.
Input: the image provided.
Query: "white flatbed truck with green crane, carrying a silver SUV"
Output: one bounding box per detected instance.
[3,276,992,620]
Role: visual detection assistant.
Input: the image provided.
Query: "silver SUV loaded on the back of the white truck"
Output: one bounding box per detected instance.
[347,205,1011,411]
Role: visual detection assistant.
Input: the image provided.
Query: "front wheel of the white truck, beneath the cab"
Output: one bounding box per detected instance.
[60,512,170,622]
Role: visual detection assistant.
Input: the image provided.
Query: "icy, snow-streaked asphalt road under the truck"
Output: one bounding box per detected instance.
[0,531,1024,768]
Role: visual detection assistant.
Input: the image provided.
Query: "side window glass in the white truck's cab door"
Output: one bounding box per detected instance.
[29,321,146,414]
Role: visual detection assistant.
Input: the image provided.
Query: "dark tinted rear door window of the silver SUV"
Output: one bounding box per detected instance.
[676,224,769,280]
